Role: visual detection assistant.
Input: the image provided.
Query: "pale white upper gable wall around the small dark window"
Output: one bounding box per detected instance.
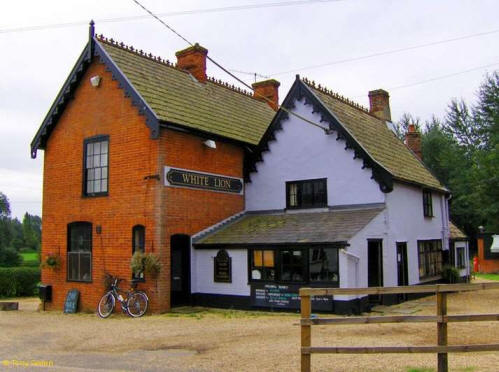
[246,97,385,211]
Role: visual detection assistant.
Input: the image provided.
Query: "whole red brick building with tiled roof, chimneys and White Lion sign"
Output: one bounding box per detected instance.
[31,26,279,312]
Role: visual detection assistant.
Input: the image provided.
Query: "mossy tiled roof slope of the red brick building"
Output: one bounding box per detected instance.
[97,38,275,145]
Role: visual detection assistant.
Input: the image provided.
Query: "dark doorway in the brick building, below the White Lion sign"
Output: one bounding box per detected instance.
[170,234,191,307]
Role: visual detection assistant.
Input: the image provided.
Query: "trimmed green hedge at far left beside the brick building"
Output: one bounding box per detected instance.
[0,267,40,297]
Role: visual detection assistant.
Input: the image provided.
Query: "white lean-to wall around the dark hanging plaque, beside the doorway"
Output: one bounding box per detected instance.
[191,249,250,296]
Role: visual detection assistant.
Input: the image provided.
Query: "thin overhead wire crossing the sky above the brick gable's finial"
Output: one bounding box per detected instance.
[0,0,346,34]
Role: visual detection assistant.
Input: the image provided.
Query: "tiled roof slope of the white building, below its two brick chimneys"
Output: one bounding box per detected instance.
[302,79,447,191]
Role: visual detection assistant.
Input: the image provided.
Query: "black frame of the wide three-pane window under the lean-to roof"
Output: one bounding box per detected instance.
[248,244,341,287]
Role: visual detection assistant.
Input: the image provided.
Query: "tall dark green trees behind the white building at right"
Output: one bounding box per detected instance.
[404,72,499,237]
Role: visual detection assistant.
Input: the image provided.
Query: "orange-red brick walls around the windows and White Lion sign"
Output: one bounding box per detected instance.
[42,59,244,313]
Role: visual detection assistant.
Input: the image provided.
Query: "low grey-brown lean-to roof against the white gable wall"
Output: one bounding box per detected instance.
[194,207,383,246]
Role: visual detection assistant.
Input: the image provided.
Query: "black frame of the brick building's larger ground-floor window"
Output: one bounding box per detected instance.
[66,221,93,283]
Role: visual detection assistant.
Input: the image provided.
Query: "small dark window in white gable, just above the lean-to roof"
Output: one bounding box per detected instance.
[286,178,327,209]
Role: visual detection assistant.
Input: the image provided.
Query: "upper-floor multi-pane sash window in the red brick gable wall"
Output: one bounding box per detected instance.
[83,136,109,196]
